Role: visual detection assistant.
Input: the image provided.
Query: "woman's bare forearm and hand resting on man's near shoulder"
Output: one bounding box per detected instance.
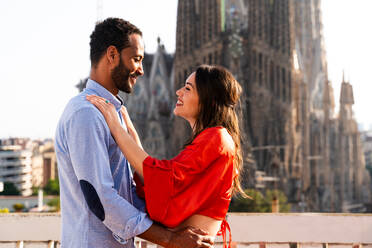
[86,95,148,177]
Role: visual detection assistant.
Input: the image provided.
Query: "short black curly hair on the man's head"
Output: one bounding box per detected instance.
[90,18,142,66]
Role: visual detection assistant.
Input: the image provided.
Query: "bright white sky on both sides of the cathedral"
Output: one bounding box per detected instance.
[0,0,372,139]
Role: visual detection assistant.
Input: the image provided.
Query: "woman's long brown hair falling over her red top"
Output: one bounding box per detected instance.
[188,65,247,197]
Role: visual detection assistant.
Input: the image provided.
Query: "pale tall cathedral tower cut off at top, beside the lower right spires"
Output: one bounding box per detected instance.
[291,0,334,211]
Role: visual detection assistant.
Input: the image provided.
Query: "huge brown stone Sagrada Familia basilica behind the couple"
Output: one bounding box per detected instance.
[77,0,371,212]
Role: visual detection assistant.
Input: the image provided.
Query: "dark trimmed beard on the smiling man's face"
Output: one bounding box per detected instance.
[111,58,138,93]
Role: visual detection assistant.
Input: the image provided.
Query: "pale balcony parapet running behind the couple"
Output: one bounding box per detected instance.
[0,213,372,248]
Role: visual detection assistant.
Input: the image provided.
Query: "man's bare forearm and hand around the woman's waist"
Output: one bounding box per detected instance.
[138,223,213,248]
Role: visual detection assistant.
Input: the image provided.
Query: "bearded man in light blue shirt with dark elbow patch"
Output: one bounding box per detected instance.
[55,18,212,248]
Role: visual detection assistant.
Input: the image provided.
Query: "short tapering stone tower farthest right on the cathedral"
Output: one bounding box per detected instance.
[328,80,371,212]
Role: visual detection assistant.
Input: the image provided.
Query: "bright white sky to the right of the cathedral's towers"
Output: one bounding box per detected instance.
[322,0,372,130]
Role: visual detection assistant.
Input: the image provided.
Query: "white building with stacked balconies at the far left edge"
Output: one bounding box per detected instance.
[0,145,32,196]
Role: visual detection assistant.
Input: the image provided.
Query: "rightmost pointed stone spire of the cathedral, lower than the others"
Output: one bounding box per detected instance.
[335,77,370,211]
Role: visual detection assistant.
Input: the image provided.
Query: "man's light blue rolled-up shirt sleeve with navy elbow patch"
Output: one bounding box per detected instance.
[65,108,152,241]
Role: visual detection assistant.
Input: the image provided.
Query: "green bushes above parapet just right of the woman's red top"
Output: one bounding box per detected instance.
[229,189,291,213]
